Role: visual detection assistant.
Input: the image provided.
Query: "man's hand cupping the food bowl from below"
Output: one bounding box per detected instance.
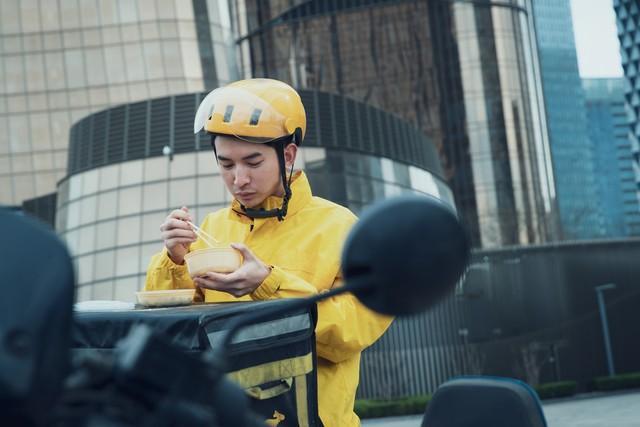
[193,243,271,297]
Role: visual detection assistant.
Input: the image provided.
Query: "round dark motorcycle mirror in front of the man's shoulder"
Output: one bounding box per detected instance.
[342,196,470,315]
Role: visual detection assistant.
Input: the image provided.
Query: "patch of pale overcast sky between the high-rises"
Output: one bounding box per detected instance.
[571,0,623,77]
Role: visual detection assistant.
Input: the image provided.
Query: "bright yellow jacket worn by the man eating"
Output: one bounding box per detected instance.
[145,172,392,427]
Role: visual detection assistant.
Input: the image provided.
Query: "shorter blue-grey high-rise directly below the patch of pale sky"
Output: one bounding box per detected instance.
[582,78,640,237]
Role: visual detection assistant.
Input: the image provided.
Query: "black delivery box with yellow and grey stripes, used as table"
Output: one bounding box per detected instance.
[72,300,322,427]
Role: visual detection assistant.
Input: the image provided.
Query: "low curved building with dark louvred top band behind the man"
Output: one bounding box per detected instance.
[56,91,454,301]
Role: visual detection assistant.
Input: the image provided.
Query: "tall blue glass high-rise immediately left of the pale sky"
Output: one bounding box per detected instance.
[533,0,605,240]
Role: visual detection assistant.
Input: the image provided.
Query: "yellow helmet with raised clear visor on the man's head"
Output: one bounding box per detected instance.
[193,79,307,145]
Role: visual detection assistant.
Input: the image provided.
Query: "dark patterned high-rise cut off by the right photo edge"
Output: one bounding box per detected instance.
[613,0,640,224]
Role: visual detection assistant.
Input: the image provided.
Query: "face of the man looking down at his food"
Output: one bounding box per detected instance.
[215,135,297,208]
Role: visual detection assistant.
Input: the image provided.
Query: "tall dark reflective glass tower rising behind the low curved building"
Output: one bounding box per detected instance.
[231,0,557,247]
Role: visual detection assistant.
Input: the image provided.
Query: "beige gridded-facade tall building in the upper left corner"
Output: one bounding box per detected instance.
[0,0,237,208]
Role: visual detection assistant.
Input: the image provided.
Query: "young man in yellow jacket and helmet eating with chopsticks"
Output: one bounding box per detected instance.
[145,79,391,427]
